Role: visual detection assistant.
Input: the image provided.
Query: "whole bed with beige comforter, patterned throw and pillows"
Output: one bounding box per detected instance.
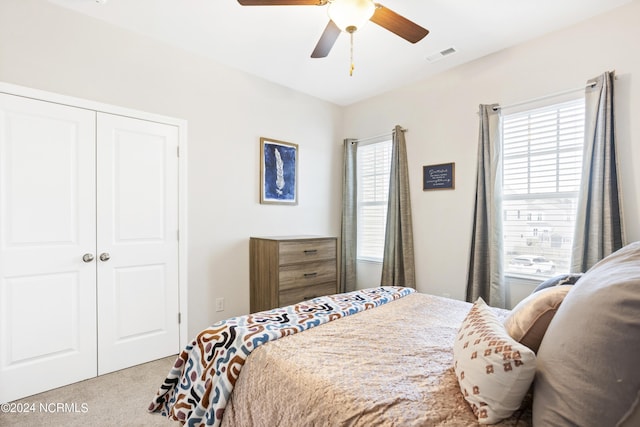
[149,242,640,427]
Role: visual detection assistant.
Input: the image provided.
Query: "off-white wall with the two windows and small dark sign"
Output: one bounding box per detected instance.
[344,1,640,306]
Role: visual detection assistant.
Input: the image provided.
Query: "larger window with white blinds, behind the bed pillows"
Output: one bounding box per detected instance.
[502,99,584,277]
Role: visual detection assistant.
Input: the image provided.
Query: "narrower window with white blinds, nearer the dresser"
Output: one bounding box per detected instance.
[357,141,391,262]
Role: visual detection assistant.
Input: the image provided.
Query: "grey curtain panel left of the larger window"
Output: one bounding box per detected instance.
[467,105,506,307]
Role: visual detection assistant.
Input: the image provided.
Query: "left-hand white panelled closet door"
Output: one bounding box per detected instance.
[0,94,96,402]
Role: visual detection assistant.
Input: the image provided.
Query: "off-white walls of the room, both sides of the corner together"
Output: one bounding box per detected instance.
[0,0,640,334]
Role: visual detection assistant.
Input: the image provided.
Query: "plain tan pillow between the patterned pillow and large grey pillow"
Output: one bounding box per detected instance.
[504,285,573,353]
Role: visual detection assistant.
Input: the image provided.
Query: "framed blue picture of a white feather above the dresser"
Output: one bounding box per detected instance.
[260,137,298,205]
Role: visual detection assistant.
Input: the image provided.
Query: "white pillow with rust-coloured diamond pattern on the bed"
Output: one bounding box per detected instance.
[453,298,536,424]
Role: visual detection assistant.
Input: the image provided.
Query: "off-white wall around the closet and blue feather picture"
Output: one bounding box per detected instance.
[0,0,342,335]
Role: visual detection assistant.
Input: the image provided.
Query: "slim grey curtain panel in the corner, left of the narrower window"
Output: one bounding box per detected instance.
[340,138,358,292]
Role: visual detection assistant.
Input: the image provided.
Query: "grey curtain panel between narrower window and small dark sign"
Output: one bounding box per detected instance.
[380,126,416,289]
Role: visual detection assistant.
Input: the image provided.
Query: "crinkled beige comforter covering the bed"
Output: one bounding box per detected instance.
[222,293,531,427]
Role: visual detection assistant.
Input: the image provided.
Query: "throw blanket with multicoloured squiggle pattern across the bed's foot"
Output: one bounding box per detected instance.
[149,286,415,426]
